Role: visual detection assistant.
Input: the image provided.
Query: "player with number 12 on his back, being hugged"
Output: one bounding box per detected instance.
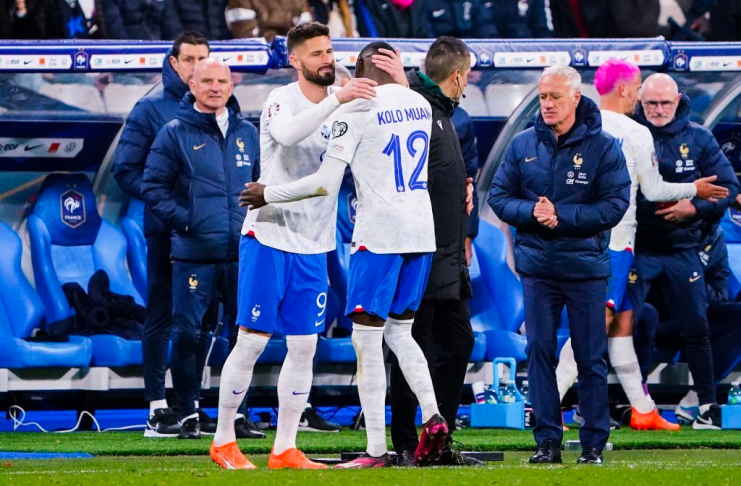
[248,42,448,468]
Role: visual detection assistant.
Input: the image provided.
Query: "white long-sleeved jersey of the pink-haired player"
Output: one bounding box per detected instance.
[600,110,697,251]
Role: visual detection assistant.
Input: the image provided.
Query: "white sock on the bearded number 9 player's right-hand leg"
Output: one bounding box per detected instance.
[273,334,317,455]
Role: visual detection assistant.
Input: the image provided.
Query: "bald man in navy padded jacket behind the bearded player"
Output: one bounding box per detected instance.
[142,59,260,438]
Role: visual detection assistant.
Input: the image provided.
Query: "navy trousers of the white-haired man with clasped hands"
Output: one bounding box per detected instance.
[522,277,610,451]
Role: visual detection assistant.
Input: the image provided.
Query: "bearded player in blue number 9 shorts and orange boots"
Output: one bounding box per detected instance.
[210,22,403,469]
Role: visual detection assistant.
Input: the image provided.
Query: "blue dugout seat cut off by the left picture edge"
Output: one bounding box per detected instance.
[0,223,93,368]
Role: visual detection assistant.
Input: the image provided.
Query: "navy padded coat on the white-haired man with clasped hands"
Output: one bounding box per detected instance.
[489,96,630,281]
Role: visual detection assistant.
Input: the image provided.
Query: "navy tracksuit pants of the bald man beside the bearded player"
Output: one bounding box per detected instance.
[171,260,239,420]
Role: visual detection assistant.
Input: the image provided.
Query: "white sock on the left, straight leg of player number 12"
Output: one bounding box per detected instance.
[352,324,388,457]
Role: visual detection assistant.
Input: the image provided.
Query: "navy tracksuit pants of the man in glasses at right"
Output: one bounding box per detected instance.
[628,249,715,405]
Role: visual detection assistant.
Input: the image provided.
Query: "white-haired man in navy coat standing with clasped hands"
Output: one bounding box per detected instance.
[489,66,630,464]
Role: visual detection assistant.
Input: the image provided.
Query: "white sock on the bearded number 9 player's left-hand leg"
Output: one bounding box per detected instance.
[214,330,270,446]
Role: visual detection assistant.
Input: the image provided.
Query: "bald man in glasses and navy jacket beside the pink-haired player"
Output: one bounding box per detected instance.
[628,74,738,429]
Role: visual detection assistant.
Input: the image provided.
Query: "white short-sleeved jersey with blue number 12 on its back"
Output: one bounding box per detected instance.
[327,84,436,253]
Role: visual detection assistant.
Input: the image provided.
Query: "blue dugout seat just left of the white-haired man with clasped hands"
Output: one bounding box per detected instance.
[469,220,526,361]
